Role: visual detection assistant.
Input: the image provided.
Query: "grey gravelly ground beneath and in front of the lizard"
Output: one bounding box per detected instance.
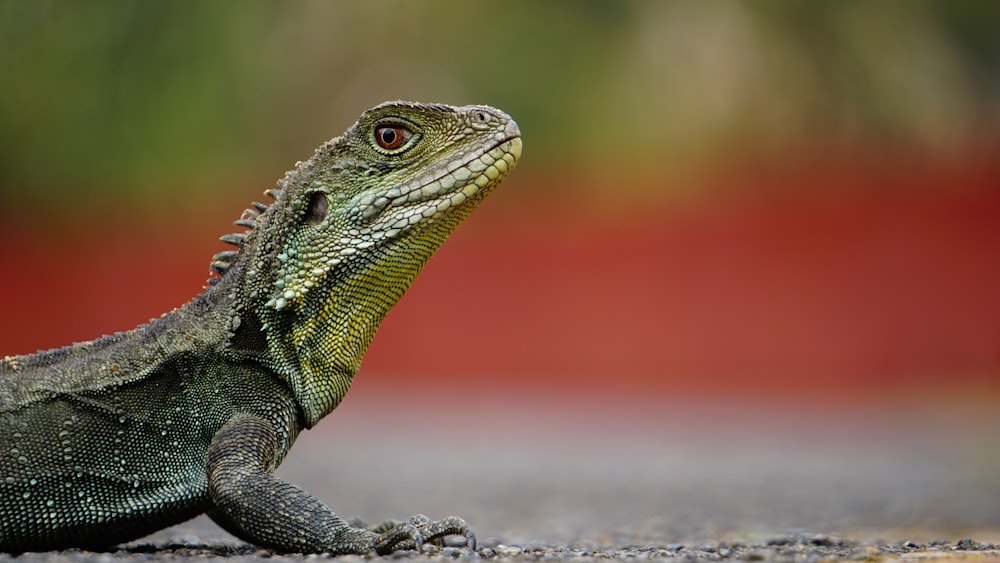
[0,394,1000,561]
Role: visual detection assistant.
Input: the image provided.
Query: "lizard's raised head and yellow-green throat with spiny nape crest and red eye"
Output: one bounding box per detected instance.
[213,102,521,426]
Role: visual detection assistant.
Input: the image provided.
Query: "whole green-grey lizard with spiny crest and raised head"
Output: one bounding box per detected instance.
[0,102,521,554]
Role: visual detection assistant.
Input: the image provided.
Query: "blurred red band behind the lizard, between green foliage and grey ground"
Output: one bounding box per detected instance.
[0,145,1000,399]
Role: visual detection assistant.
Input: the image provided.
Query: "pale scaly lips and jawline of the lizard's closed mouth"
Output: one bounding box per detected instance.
[361,137,521,239]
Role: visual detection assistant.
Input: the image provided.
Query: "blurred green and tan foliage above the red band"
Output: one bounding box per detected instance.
[0,0,1000,201]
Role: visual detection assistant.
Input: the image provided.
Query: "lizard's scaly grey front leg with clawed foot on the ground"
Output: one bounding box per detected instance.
[207,415,475,554]
